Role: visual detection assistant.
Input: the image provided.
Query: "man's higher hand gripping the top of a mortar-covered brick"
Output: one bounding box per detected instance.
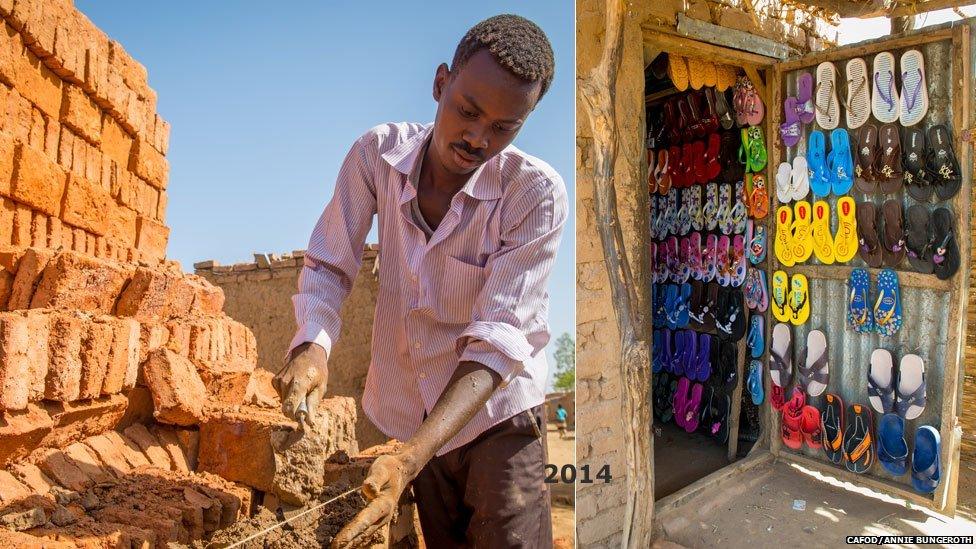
[271,342,329,425]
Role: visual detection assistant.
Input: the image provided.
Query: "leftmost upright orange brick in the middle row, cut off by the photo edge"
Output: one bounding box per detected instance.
[0,313,31,411]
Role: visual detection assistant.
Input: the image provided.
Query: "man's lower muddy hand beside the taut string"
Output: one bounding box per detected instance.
[332,454,419,549]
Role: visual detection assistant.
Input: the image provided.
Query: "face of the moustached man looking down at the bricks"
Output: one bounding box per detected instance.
[431,49,542,175]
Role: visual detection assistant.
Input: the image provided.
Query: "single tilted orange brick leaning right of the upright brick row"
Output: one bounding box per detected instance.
[143,349,207,425]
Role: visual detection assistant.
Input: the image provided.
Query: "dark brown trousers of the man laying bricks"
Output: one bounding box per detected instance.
[413,406,552,549]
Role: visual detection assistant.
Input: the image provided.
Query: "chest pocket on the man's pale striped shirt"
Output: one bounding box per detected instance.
[428,255,486,324]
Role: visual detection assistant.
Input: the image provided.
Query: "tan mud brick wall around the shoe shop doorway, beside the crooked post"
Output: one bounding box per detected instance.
[576,0,836,547]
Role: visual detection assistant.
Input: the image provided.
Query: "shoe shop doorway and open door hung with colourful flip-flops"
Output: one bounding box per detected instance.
[578,0,974,531]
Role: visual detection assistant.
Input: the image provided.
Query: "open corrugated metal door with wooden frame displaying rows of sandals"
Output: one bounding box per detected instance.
[763,21,972,510]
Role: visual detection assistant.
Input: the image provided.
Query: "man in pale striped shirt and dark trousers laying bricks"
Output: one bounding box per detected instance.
[275,15,568,547]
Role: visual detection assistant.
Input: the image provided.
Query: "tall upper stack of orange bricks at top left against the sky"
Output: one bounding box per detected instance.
[0,0,169,263]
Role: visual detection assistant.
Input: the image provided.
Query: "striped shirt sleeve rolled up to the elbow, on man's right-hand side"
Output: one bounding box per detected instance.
[457,176,569,387]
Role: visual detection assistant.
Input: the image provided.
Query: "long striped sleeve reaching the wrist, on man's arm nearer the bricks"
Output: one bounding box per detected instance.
[284,133,376,360]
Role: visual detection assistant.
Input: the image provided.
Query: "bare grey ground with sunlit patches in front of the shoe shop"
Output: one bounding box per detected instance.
[655,456,976,549]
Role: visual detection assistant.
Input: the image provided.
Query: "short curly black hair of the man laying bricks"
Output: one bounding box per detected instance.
[451,14,556,99]
